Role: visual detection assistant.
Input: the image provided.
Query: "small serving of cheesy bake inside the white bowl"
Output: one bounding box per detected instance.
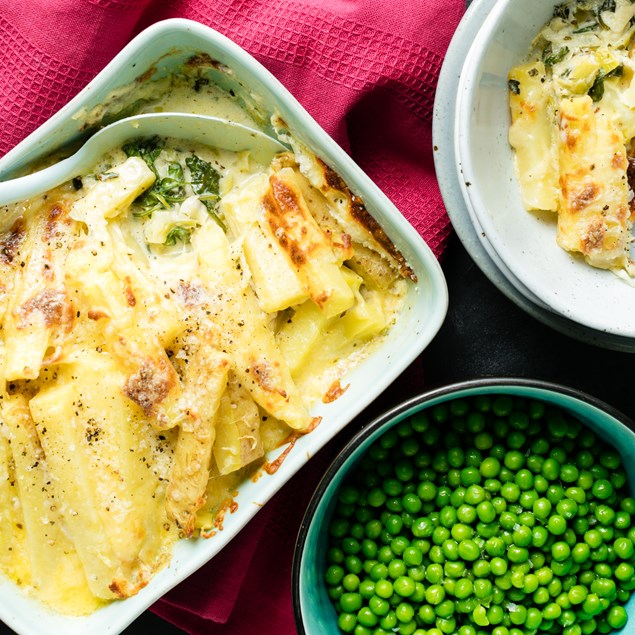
[509,0,635,276]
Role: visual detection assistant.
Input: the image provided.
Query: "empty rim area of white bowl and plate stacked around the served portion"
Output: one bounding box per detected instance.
[433,0,635,352]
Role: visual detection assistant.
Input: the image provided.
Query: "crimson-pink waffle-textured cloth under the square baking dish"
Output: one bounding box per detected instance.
[0,0,464,635]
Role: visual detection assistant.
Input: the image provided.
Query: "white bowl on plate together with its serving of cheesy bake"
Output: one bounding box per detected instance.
[437,0,635,351]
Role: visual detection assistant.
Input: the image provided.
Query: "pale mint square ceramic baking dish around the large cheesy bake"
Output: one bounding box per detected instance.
[0,19,448,635]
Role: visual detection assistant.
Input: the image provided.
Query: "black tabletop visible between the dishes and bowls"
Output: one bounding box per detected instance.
[0,236,635,635]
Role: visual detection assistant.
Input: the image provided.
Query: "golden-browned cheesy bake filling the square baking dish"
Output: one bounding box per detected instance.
[0,72,414,614]
